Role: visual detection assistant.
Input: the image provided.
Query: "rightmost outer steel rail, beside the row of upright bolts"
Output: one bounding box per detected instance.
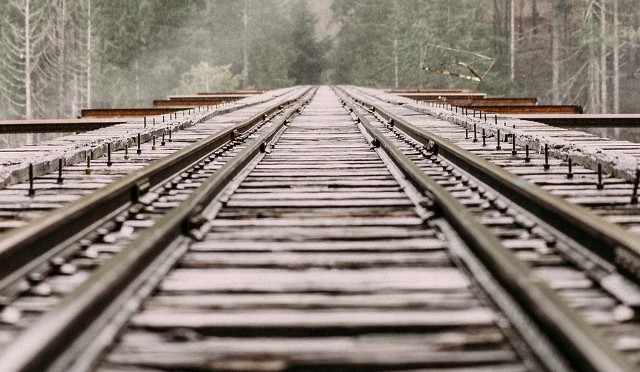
[344,88,640,284]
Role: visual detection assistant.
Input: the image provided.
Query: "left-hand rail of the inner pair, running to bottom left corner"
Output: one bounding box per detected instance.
[0,90,316,372]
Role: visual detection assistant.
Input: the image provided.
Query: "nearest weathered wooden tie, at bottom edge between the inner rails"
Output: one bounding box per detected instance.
[108,332,522,371]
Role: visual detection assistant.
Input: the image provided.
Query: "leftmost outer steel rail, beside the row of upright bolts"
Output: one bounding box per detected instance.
[0,91,304,288]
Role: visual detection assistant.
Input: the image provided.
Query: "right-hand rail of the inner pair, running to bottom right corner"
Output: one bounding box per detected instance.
[339,91,636,372]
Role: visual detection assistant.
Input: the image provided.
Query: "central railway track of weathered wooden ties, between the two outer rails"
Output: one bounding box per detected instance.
[0,87,640,371]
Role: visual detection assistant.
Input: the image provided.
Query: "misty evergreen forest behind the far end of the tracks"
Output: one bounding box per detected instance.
[0,0,640,119]
